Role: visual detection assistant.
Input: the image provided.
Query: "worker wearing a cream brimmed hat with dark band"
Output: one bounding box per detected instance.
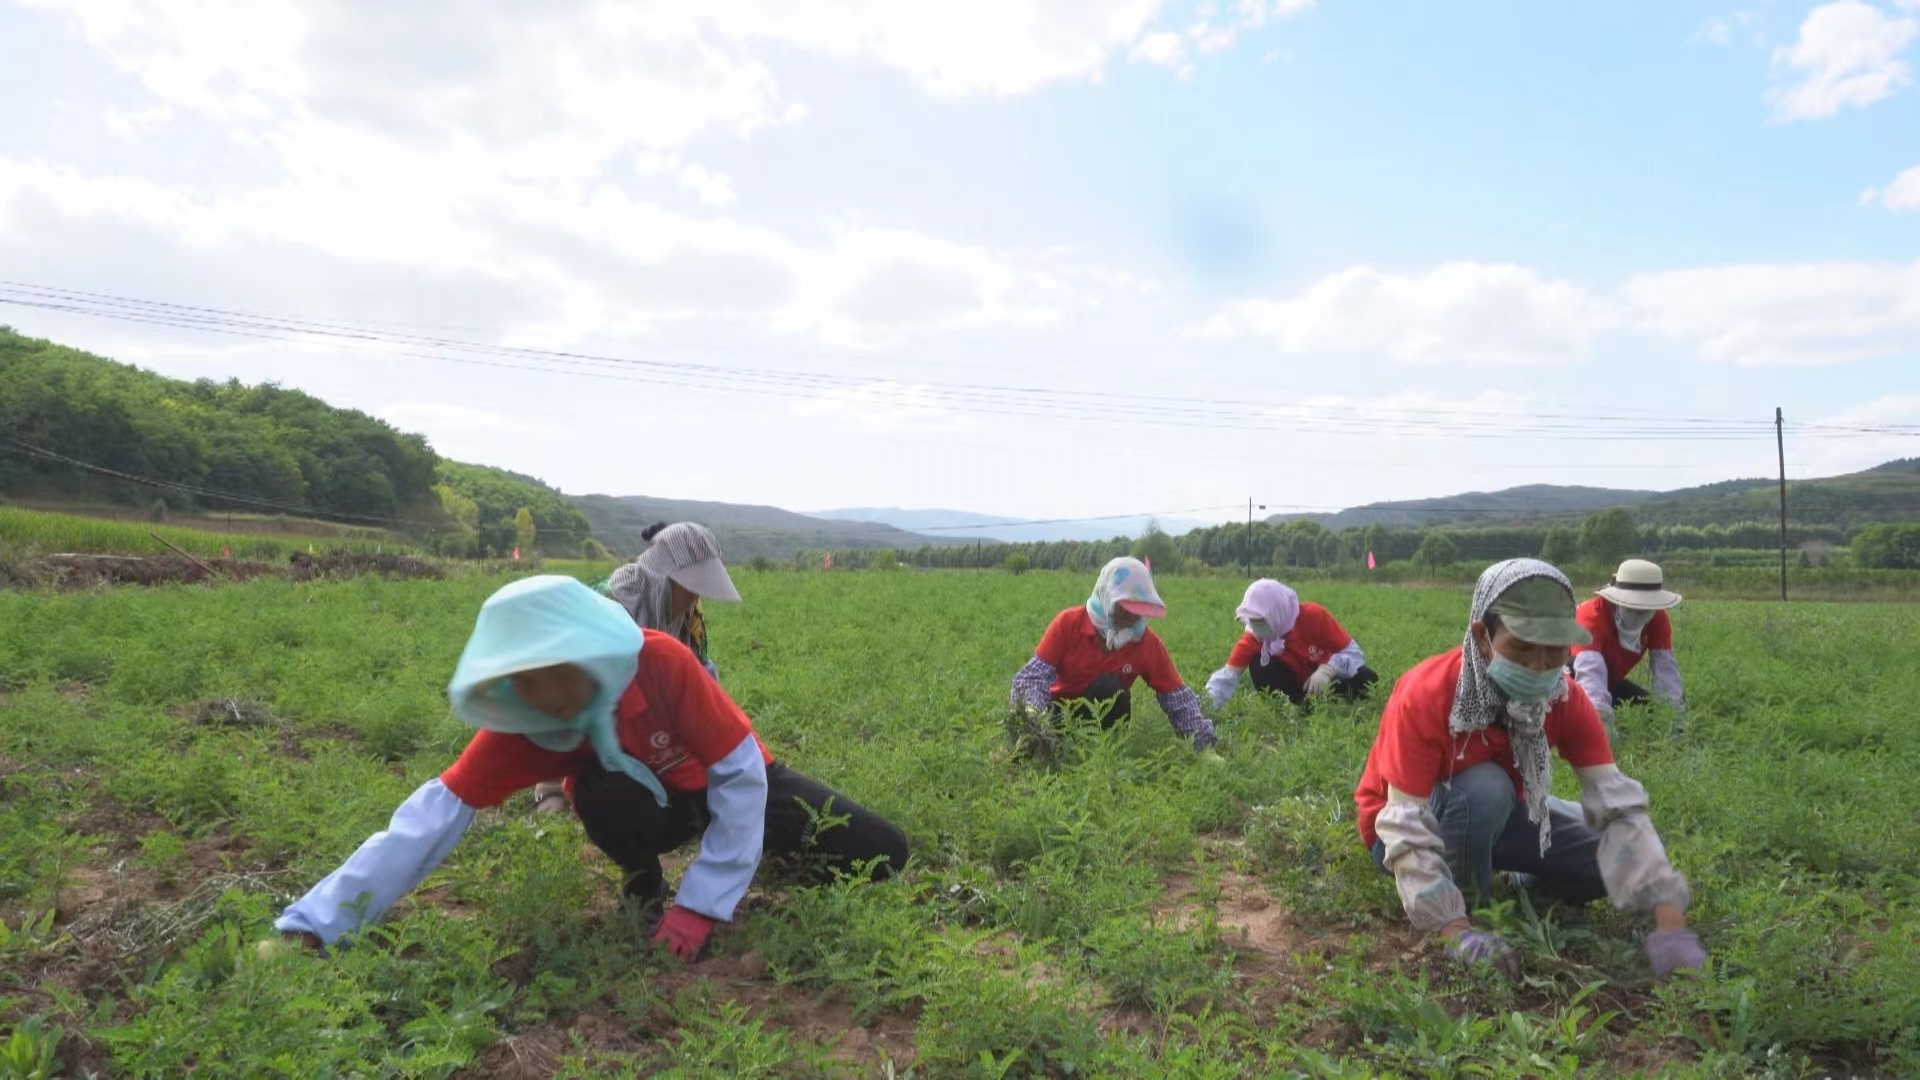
[1572,559,1686,732]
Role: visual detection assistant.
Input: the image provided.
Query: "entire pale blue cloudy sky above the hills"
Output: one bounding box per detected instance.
[0,0,1920,517]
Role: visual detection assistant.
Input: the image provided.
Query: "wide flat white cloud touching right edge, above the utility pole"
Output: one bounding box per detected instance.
[1622,263,1920,367]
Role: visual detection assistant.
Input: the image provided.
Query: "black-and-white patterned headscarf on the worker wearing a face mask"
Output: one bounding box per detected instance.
[1448,559,1572,855]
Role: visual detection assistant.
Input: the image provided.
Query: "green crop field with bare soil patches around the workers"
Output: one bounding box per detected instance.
[0,571,1920,1078]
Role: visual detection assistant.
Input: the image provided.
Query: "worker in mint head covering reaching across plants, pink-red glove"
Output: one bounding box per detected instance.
[264,575,906,961]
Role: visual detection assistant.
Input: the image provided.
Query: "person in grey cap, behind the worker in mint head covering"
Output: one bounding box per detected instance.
[534,521,739,813]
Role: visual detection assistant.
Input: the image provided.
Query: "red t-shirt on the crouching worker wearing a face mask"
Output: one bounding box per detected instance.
[1354,650,1613,847]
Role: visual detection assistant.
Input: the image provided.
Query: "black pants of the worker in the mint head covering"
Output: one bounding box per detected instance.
[574,761,906,901]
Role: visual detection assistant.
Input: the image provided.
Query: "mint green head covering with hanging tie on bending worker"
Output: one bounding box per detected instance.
[447,575,666,807]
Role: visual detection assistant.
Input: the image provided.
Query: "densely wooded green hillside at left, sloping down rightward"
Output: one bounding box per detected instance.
[0,327,591,555]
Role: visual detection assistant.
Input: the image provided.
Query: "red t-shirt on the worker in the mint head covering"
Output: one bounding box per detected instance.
[440,630,774,809]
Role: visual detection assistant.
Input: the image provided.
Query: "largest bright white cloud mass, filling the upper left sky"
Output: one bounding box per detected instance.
[0,0,1128,346]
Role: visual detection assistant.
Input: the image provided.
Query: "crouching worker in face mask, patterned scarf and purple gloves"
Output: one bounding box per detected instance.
[1354,559,1707,978]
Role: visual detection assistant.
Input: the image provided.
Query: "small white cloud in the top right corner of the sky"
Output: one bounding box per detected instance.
[1768,0,1920,121]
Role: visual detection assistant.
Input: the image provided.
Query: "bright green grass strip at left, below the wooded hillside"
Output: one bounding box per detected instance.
[0,505,413,563]
